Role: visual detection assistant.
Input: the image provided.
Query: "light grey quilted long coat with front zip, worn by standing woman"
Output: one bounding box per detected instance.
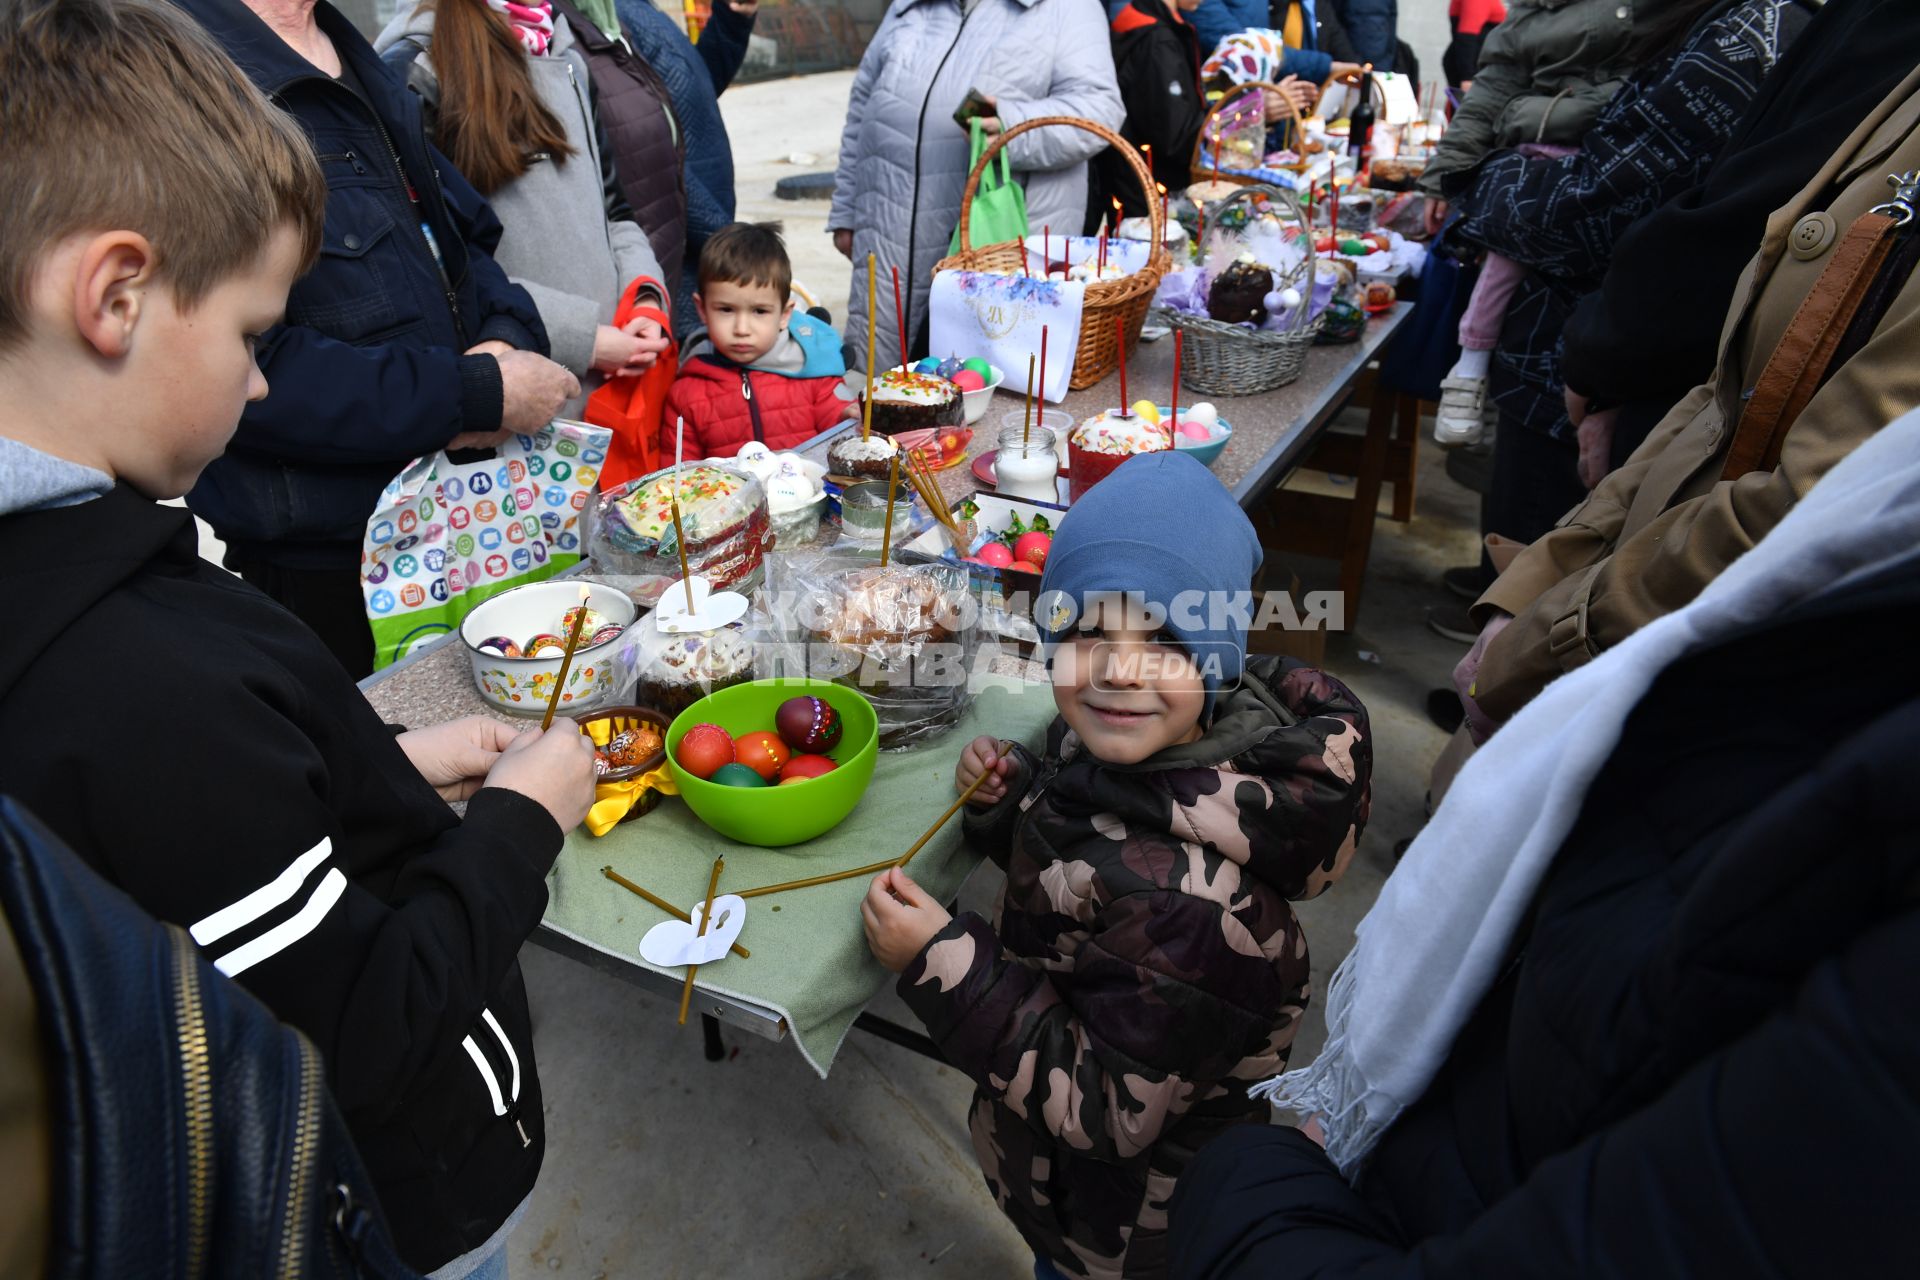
[828,0,1125,368]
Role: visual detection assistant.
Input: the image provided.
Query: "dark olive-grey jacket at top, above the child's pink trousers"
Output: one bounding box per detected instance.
[1421,0,1680,196]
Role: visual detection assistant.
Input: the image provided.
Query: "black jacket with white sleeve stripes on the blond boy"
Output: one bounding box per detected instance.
[0,487,561,1270]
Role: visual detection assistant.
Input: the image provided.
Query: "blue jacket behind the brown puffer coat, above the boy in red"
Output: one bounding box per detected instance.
[614,0,753,338]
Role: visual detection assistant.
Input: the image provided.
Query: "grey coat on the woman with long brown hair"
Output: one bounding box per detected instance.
[374,10,666,397]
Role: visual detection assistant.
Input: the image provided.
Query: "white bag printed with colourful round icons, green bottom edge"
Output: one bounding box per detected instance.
[361,418,611,670]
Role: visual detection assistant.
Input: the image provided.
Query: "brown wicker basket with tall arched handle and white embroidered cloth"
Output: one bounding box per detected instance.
[933,115,1173,391]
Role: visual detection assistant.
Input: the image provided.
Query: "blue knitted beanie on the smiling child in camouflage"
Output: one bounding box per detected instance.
[1033,449,1261,723]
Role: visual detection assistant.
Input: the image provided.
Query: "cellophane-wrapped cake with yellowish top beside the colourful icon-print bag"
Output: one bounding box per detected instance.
[588,462,770,606]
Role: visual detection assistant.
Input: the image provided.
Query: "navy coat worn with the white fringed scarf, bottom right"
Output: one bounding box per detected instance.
[1169,560,1920,1280]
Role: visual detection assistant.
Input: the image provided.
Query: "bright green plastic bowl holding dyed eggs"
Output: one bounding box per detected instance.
[666,679,879,848]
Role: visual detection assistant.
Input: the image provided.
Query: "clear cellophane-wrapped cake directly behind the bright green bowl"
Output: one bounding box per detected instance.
[762,553,981,750]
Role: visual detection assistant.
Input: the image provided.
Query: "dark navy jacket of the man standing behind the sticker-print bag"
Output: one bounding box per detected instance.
[177,0,547,568]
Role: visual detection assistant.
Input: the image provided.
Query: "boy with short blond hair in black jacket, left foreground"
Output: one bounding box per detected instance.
[0,0,593,1274]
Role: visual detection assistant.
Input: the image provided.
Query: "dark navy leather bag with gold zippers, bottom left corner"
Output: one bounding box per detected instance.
[0,796,419,1280]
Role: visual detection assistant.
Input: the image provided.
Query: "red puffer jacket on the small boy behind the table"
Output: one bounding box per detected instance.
[660,355,847,459]
